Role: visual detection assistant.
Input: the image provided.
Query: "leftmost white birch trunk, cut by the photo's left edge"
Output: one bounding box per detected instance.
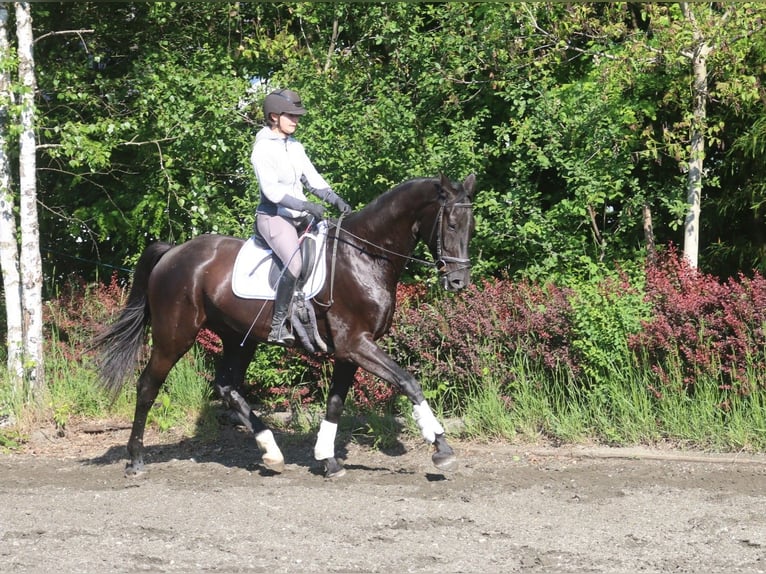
[0,4,24,385]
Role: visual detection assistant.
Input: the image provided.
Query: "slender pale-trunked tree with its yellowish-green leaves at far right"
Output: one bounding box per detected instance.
[646,2,763,267]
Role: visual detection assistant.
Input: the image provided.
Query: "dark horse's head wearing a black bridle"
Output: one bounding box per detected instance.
[427,174,476,291]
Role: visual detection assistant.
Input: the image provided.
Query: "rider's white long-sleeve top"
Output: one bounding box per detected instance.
[250,126,330,218]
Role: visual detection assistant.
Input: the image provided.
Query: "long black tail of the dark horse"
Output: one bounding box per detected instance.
[90,242,172,397]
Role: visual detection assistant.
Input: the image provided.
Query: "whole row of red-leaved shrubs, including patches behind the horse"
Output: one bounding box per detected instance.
[46,248,766,418]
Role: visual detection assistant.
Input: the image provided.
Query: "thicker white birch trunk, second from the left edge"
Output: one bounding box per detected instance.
[16,2,45,400]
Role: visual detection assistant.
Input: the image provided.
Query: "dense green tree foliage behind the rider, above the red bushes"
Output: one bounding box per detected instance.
[7,2,766,280]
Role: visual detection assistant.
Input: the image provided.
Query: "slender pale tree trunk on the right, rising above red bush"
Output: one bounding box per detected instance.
[681,2,711,267]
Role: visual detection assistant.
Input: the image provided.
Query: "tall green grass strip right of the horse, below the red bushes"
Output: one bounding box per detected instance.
[412,344,766,452]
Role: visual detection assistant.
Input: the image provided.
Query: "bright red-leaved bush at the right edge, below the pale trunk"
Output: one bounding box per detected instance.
[630,248,766,394]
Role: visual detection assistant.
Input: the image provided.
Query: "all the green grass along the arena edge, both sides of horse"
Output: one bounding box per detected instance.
[0,336,766,452]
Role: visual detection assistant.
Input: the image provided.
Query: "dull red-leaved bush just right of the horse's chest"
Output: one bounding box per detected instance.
[388,279,579,396]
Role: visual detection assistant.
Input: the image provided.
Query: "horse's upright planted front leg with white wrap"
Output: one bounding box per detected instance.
[314,360,358,478]
